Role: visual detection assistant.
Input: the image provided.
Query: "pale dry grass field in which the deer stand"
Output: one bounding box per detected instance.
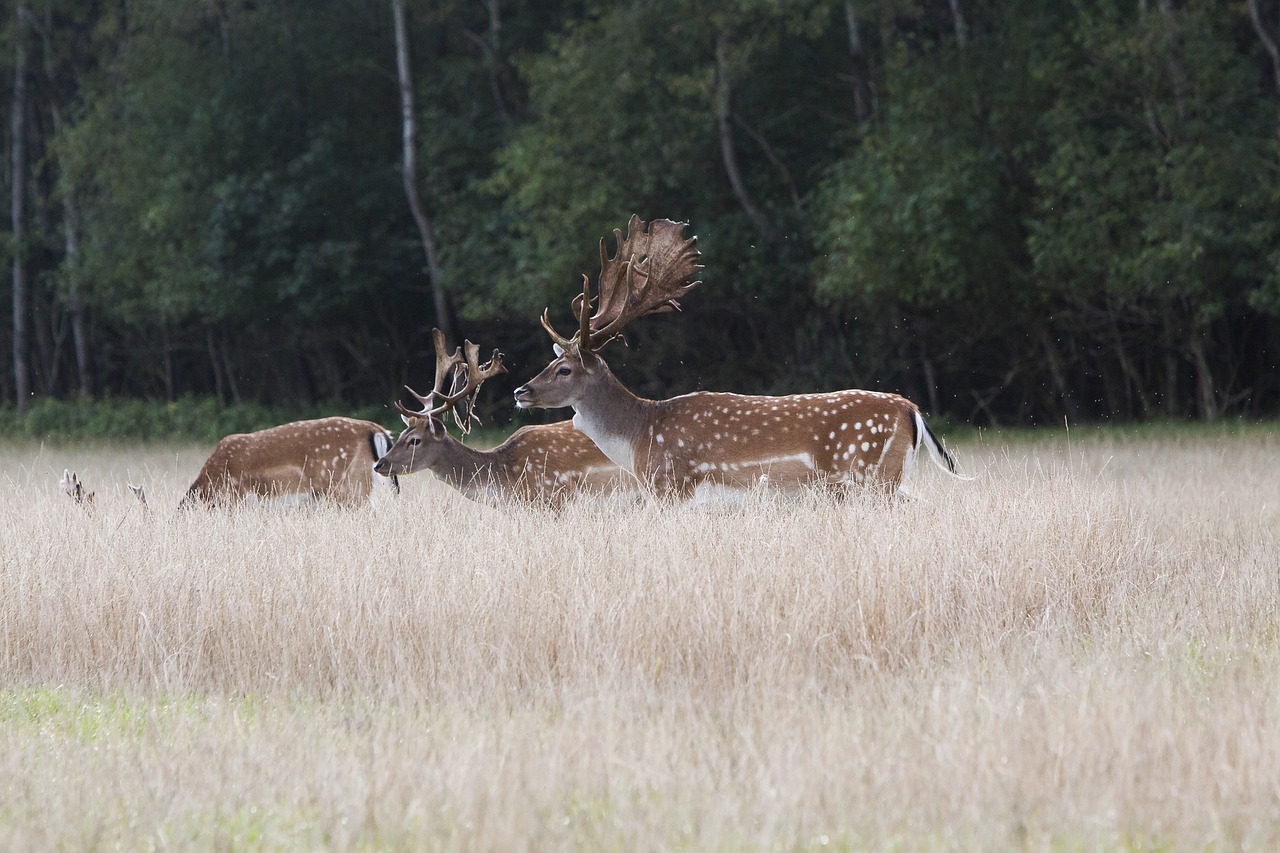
[0,428,1280,850]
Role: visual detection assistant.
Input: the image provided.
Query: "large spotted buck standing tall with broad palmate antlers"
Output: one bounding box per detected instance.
[516,216,955,500]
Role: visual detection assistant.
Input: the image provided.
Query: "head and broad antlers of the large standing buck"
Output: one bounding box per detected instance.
[516,215,701,409]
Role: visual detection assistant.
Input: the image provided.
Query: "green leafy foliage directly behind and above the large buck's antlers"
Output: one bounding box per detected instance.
[489,4,714,315]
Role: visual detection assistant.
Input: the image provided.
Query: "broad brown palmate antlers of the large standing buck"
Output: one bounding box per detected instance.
[543,214,701,352]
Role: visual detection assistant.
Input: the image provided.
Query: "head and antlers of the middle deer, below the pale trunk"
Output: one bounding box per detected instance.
[374,329,507,476]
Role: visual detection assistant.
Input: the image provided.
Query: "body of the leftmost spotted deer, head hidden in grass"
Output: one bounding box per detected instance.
[180,418,399,507]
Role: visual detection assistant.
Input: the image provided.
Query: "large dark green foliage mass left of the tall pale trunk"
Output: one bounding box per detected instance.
[60,0,404,324]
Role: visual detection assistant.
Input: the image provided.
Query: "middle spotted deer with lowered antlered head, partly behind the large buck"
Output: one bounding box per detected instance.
[374,329,634,507]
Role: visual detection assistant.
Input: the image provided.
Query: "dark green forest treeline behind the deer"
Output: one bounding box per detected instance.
[0,0,1280,423]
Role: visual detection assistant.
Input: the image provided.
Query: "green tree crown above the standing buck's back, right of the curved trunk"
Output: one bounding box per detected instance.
[814,54,1016,314]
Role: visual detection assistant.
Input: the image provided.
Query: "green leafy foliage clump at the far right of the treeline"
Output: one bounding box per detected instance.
[1028,3,1280,320]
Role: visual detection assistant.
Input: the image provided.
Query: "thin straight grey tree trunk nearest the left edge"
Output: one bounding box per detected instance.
[10,3,31,414]
